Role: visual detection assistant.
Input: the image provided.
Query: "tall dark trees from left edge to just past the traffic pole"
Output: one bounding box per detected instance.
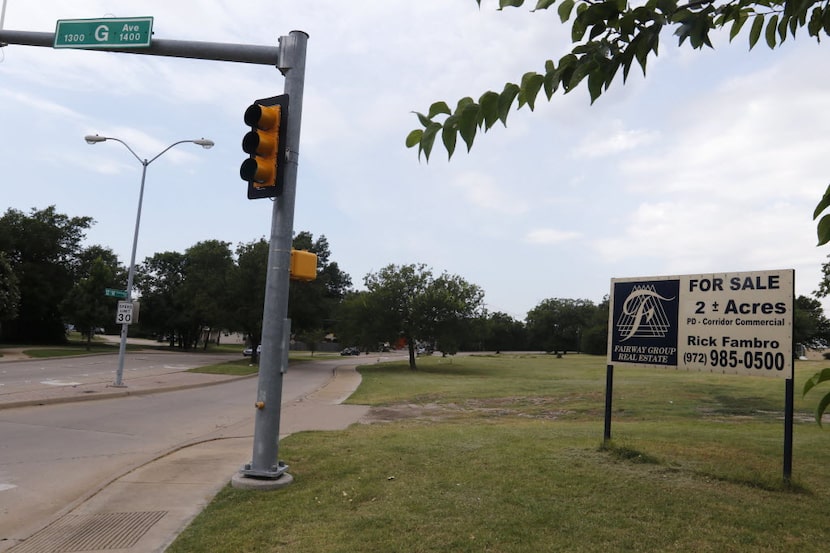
[0,206,351,349]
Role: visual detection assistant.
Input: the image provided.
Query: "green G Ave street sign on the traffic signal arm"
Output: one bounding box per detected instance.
[54,17,153,48]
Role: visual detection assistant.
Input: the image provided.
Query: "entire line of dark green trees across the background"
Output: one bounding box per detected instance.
[0,206,830,360]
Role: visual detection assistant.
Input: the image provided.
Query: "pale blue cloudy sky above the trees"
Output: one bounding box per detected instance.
[0,0,830,320]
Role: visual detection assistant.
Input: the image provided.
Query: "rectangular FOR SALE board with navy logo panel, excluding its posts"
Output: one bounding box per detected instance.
[608,269,795,378]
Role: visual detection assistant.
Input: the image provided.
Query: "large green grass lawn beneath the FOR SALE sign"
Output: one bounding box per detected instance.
[167,354,830,553]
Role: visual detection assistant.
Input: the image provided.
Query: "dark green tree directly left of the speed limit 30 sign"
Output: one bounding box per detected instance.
[62,257,116,349]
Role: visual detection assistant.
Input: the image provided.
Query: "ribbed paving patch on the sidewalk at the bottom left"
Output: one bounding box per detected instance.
[9,511,167,553]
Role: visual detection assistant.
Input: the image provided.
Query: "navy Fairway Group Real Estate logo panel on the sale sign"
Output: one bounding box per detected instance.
[608,279,680,366]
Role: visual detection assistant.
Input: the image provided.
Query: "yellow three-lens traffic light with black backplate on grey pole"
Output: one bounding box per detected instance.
[239,94,288,200]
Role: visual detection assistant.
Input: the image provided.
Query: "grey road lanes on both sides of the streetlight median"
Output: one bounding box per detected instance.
[0,353,342,550]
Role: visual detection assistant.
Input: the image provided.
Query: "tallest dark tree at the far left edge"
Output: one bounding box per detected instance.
[0,206,92,343]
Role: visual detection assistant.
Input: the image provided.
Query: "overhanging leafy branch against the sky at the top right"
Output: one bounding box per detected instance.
[406,0,830,160]
